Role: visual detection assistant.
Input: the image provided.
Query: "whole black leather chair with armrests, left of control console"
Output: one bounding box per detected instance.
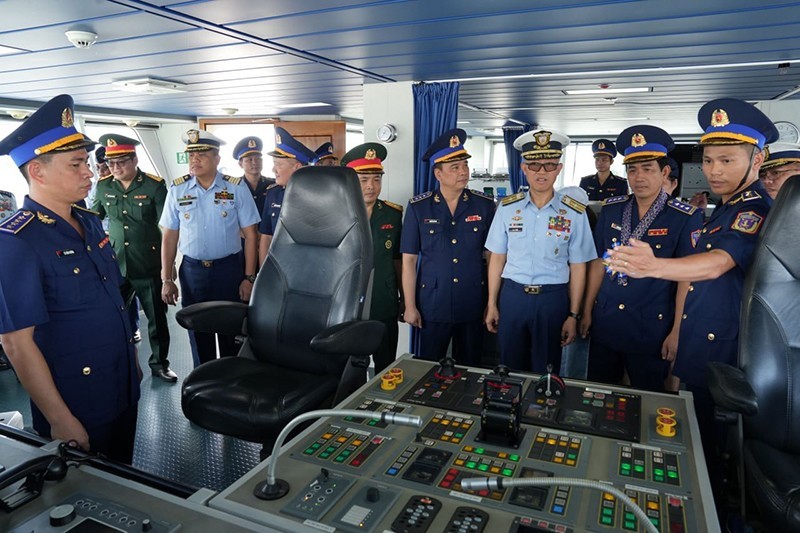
[177,167,385,453]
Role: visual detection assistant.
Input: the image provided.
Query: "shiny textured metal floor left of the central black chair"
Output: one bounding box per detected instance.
[0,307,261,491]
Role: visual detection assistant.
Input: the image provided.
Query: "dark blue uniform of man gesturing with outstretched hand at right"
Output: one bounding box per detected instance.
[672,181,772,390]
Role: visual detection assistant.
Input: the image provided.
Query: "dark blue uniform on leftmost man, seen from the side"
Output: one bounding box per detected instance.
[0,196,139,460]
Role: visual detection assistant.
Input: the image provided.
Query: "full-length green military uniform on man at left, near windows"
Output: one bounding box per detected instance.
[93,160,170,372]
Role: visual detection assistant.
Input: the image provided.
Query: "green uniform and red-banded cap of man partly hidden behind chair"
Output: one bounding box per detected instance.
[341,143,403,374]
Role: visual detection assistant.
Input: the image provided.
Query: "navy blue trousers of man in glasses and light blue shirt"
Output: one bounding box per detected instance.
[497,278,569,374]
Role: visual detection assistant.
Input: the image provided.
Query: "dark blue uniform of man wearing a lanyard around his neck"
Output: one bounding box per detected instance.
[588,193,703,391]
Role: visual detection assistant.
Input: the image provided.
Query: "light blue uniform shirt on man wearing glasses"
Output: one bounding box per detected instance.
[486,191,597,285]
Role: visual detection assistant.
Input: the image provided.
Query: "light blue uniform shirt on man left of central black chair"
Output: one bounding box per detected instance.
[159,172,261,260]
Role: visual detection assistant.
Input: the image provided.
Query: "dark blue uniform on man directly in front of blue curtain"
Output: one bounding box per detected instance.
[400,189,494,364]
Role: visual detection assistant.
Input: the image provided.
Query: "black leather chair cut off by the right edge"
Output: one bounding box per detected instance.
[709,176,800,531]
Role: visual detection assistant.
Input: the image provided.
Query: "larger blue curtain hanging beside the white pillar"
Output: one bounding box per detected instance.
[413,82,459,196]
